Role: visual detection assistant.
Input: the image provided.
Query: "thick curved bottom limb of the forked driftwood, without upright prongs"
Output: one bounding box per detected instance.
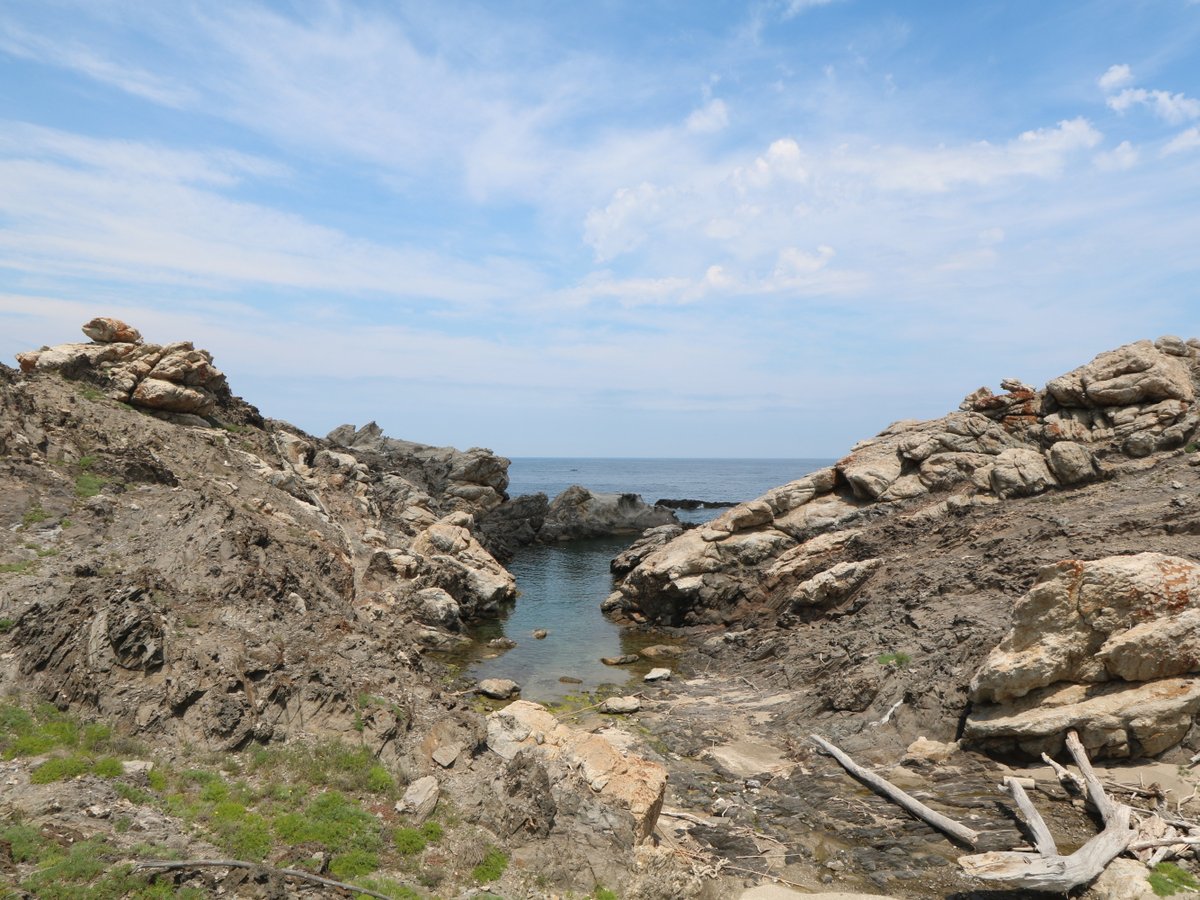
[959,805,1134,893]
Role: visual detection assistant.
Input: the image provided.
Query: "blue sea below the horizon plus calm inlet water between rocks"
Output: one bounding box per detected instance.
[460,457,833,702]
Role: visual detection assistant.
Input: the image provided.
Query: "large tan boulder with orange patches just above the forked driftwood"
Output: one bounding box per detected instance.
[966,553,1200,756]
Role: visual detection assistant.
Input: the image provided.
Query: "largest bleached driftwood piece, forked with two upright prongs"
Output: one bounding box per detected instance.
[959,732,1138,893]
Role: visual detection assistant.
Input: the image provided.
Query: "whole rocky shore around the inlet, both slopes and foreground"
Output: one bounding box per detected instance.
[0,319,1200,898]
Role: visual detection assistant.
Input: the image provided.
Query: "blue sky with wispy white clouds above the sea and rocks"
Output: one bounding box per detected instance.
[0,0,1200,457]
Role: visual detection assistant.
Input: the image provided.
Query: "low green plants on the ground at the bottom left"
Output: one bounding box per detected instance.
[0,702,508,900]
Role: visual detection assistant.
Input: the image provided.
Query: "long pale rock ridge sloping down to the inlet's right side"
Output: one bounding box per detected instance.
[605,336,1200,624]
